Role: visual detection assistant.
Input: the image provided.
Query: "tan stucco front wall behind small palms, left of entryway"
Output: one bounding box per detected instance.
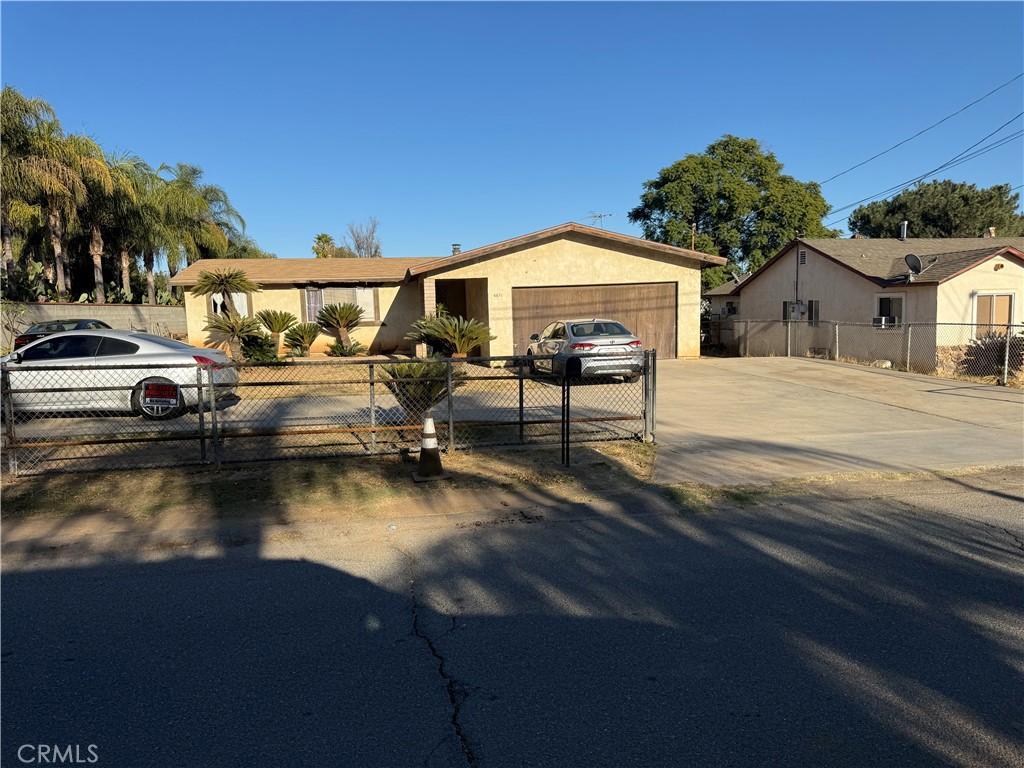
[185,285,420,354]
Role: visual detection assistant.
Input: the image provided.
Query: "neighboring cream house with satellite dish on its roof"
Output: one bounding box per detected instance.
[730,238,1024,371]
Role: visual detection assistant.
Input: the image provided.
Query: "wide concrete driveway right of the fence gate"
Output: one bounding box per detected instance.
[655,357,1024,485]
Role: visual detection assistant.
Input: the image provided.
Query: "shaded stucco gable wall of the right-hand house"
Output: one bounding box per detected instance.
[735,241,935,324]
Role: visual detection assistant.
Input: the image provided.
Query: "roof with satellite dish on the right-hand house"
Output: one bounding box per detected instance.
[731,238,1024,294]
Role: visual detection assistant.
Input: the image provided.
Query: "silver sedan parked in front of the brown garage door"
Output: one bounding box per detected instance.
[526,318,643,381]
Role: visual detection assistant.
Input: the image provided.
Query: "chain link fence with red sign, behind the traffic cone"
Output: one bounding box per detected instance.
[2,351,656,474]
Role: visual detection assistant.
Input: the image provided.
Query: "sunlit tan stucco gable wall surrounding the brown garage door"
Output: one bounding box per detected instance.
[415,236,700,357]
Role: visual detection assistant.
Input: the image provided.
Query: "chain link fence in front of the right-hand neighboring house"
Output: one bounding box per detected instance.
[733,321,1024,388]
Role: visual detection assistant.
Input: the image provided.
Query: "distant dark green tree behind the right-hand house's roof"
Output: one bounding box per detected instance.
[849,179,1024,238]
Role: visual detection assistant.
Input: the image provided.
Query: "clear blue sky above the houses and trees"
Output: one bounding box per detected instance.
[0,2,1024,256]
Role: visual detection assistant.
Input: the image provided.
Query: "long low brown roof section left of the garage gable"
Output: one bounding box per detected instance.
[170,256,437,286]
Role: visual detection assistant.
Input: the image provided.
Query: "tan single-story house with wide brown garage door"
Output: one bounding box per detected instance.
[171,223,725,357]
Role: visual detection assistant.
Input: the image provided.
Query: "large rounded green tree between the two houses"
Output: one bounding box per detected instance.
[629,135,839,288]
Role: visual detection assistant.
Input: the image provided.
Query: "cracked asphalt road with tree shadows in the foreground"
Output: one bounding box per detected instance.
[2,472,1024,768]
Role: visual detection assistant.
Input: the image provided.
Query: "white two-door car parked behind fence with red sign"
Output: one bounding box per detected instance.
[0,330,239,420]
